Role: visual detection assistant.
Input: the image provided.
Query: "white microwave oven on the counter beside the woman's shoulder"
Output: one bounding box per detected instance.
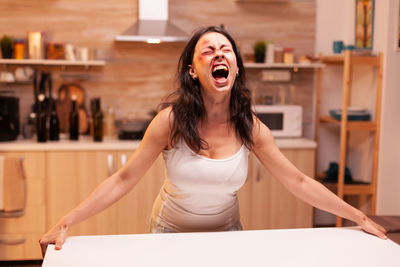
[253,105,303,137]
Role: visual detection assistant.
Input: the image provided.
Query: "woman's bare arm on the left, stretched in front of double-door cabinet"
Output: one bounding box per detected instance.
[39,108,170,256]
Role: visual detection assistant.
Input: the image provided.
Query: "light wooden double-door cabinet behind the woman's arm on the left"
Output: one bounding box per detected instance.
[46,151,164,235]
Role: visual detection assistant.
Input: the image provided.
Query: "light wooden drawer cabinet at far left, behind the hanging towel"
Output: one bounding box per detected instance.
[0,151,46,261]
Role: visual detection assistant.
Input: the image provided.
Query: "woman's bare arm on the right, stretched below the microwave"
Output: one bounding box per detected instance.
[253,119,386,239]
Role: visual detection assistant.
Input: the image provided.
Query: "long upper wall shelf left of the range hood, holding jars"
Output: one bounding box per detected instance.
[0,59,106,67]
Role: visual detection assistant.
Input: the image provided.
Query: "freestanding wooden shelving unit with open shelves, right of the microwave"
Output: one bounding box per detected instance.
[315,51,383,226]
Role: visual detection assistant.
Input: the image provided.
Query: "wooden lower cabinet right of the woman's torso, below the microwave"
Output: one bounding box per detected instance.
[239,149,315,230]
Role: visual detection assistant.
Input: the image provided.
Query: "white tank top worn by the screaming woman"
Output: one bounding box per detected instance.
[152,141,249,232]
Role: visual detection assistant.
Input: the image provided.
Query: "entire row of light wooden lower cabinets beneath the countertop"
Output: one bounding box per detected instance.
[0,146,315,261]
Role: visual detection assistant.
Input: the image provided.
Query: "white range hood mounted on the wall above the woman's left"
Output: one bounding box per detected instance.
[115,0,188,43]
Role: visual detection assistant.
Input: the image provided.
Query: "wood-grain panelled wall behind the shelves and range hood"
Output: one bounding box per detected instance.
[0,0,315,137]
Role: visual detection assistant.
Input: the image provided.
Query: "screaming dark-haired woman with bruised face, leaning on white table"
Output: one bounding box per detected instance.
[40,27,386,253]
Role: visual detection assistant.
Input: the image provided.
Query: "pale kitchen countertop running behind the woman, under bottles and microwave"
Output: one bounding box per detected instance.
[0,136,317,152]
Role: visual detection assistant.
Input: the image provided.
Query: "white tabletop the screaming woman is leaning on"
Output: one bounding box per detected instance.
[43,228,400,267]
